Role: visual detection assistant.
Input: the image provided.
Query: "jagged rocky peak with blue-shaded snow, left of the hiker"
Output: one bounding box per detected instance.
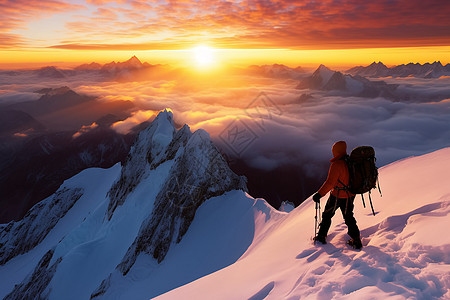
[0,111,248,299]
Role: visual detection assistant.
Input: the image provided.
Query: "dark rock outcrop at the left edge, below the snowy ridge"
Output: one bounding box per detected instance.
[0,188,83,265]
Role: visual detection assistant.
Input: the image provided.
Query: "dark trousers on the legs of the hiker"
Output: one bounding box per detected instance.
[317,194,360,239]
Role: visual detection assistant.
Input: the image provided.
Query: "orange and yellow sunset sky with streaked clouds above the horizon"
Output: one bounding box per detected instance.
[0,0,450,67]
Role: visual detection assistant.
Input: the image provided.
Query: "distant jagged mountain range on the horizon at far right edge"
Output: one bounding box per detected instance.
[345,61,450,78]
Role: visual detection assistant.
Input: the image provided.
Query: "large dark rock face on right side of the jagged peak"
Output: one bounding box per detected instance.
[119,130,246,274]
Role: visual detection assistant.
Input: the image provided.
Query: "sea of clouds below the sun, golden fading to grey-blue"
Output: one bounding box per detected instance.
[0,69,450,202]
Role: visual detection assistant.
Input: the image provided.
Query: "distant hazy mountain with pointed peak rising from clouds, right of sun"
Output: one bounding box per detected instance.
[297,65,399,99]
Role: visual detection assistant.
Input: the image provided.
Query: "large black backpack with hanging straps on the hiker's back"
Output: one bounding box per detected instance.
[344,146,381,215]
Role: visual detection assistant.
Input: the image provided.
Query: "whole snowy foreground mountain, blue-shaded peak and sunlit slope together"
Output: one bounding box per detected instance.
[0,111,450,299]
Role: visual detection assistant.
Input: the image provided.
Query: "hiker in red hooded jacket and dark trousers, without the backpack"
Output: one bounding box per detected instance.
[313,141,362,249]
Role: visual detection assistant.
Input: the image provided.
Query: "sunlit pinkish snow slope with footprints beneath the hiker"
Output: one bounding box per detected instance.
[156,148,450,300]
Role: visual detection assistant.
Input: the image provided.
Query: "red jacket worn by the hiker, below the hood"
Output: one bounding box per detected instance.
[318,154,354,198]
